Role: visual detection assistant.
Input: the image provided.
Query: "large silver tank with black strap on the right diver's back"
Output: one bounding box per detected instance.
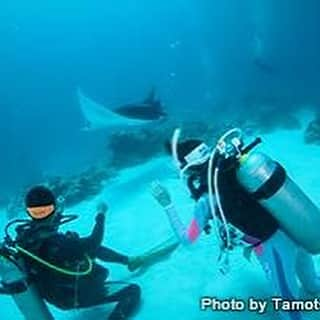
[237,153,320,254]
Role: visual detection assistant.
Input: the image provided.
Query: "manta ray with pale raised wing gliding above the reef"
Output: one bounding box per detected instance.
[77,88,167,131]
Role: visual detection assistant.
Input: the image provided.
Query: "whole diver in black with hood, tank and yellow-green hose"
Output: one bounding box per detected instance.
[0,186,177,320]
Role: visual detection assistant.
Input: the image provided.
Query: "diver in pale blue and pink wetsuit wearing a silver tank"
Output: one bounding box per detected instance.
[151,129,320,319]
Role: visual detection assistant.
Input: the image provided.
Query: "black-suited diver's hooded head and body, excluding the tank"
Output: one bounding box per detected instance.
[1,186,140,320]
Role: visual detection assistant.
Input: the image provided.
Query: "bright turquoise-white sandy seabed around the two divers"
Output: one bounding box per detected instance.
[0,110,320,320]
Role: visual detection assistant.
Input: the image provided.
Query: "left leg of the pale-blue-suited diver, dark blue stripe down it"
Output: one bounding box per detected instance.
[257,231,304,320]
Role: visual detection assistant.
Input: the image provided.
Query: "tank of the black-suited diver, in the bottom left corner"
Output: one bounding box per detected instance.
[0,245,54,320]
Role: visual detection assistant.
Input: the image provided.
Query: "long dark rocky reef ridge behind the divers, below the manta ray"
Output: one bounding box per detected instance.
[7,107,304,219]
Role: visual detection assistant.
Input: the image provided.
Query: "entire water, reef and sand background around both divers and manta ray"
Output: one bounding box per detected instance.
[0,0,320,320]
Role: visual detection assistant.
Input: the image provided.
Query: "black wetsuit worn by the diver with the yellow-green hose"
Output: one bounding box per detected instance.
[17,215,140,320]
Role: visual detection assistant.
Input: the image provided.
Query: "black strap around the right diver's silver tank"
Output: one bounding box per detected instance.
[251,163,287,200]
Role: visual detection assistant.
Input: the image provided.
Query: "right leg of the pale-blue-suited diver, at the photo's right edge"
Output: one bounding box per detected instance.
[296,248,320,295]
